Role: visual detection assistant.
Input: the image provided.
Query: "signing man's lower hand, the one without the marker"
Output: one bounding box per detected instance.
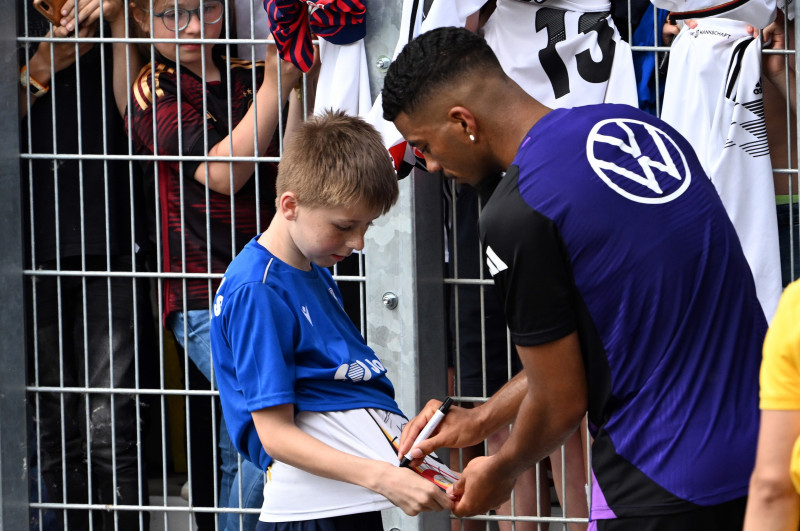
[447,456,516,517]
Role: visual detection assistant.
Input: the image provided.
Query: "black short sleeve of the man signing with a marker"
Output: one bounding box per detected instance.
[480,166,577,346]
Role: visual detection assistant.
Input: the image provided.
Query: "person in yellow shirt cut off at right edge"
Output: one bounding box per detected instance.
[744,281,800,531]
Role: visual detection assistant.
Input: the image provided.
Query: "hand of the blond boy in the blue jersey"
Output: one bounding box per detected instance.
[374,463,453,516]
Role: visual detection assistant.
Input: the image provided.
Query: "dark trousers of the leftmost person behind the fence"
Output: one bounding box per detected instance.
[29,256,149,530]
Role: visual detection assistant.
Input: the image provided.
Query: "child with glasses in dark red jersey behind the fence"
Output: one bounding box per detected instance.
[126,0,301,530]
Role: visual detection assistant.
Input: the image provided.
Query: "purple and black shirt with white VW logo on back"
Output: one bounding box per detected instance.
[480,105,767,518]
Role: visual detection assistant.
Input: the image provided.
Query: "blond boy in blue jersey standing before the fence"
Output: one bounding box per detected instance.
[211,111,451,531]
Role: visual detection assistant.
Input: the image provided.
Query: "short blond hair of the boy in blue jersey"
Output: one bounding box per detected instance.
[275,110,399,214]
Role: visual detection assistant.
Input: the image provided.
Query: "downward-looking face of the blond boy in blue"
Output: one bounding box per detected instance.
[290,204,380,269]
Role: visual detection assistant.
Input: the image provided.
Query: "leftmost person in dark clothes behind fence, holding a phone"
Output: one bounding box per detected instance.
[16,0,153,530]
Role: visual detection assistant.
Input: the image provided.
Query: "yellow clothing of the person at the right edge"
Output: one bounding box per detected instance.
[760,280,800,493]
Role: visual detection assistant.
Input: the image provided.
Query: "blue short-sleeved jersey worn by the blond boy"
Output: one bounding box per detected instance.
[211,238,402,469]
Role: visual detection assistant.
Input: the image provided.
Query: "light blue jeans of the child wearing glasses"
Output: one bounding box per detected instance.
[167,310,264,529]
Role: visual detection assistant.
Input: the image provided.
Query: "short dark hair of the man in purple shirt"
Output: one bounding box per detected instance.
[381,27,503,121]
